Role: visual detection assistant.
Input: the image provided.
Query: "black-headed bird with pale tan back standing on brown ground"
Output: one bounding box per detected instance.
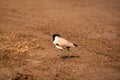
[52,34,78,52]
